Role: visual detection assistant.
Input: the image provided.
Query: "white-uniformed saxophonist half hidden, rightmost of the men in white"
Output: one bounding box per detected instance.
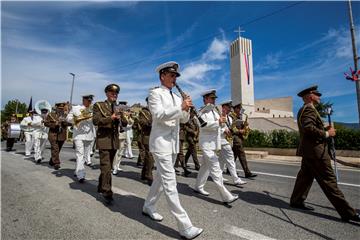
[219,100,246,185]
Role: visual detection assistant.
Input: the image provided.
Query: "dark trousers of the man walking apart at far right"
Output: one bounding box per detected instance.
[290,158,356,218]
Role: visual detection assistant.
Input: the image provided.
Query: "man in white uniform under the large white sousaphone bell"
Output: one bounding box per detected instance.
[32,106,51,163]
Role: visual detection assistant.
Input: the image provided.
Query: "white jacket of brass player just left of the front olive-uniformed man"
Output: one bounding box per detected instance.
[66,105,95,141]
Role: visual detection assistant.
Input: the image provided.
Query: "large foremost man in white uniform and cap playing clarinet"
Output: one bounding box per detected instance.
[143,62,203,239]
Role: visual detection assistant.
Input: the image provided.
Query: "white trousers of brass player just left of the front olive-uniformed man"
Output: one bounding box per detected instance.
[74,140,92,180]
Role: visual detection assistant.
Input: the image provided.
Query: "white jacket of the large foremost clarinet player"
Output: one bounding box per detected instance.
[149,86,190,154]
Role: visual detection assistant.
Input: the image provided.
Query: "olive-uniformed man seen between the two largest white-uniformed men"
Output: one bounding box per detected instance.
[184,111,200,171]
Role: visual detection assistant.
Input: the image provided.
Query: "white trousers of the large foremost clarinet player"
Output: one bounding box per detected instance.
[144,153,192,231]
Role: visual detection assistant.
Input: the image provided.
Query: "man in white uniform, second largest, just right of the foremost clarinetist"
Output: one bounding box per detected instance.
[194,89,239,204]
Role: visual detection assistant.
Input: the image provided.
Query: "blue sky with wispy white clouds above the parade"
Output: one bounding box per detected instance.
[1,1,360,122]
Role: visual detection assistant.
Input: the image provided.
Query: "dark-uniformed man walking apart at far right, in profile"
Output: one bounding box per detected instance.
[290,86,360,222]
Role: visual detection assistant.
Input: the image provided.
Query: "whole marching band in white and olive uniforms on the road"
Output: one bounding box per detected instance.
[2,62,360,239]
